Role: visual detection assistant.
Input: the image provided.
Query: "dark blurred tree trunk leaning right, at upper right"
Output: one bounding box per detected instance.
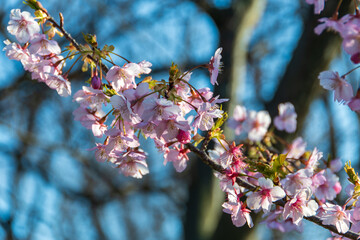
[266,0,352,131]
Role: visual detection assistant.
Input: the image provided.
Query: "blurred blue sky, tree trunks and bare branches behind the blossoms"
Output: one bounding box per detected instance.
[0,0,360,240]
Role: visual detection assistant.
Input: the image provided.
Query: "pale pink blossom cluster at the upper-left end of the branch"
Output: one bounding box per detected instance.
[3,9,71,97]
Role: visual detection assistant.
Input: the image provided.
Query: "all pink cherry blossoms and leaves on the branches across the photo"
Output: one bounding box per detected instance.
[4,0,360,239]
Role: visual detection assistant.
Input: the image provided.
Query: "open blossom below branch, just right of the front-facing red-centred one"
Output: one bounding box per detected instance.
[283,189,319,225]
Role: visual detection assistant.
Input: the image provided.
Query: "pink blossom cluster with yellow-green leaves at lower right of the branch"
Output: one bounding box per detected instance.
[215,106,355,233]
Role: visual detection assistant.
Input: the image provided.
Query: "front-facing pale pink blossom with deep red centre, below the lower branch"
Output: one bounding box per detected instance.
[246,177,286,212]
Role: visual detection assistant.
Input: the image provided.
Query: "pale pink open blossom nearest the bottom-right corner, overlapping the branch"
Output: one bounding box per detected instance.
[321,205,351,233]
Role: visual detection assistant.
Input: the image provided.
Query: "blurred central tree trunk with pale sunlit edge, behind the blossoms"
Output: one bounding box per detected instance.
[184,0,266,239]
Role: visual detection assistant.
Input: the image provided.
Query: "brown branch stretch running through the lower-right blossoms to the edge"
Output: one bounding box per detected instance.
[186,143,360,240]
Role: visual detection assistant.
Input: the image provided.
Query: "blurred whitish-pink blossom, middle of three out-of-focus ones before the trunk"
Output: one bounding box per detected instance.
[245,111,271,141]
